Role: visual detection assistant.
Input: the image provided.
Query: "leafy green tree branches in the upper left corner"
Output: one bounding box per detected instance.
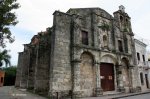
[0,0,19,47]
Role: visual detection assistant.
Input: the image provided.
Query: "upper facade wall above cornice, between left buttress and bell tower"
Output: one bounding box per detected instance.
[68,8,114,49]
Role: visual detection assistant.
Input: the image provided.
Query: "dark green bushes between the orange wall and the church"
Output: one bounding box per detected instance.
[3,66,17,86]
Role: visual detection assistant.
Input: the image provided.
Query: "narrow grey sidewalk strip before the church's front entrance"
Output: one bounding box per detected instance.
[80,90,150,99]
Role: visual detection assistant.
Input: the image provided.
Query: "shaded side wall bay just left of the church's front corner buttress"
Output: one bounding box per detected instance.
[34,35,50,94]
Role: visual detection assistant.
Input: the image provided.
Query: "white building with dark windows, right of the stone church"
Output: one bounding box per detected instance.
[135,39,150,91]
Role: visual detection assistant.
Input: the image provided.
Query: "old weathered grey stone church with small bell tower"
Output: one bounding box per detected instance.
[15,6,141,97]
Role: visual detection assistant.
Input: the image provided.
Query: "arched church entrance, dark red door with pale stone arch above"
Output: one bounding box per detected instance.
[100,54,116,92]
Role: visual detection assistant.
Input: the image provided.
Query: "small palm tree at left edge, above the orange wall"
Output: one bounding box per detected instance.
[0,50,11,67]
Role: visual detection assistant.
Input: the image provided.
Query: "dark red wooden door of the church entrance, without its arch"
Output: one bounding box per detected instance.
[100,63,115,91]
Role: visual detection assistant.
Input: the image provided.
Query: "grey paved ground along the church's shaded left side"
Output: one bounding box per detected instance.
[0,86,47,99]
